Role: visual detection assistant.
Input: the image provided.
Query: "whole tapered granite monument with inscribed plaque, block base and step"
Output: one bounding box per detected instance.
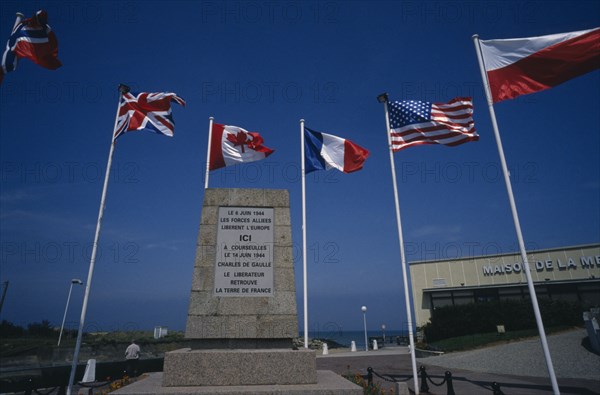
[113,189,362,395]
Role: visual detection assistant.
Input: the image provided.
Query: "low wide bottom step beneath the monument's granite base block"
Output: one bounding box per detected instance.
[113,370,363,395]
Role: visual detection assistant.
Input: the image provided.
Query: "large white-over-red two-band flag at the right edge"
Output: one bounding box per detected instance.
[480,28,600,103]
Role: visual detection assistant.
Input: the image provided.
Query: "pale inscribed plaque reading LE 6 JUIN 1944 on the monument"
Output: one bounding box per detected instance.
[214,207,274,297]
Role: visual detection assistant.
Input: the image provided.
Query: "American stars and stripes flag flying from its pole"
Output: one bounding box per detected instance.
[388,97,479,151]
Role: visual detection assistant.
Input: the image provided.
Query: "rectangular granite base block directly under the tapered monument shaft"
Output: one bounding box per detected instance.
[163,348,317,387]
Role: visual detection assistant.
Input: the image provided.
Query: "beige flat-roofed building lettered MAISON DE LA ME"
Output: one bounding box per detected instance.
[410,244,600,326]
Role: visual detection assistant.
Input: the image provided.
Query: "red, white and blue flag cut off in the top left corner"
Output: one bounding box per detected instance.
[0,10,62,83]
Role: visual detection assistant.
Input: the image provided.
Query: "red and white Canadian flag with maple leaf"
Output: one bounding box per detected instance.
[209,123,274,170]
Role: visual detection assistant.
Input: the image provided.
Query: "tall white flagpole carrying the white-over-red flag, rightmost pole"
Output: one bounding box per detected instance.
[473,34,560,395]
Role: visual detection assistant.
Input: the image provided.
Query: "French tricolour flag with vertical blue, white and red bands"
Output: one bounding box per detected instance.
[304,128,369,174]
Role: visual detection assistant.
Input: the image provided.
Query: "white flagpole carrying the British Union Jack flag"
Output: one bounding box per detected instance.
[67,85,129,395]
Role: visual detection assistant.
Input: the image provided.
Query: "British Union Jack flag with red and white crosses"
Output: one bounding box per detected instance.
[114,92,185,140]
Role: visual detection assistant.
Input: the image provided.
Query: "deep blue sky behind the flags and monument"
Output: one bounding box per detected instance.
[0,1,600,331]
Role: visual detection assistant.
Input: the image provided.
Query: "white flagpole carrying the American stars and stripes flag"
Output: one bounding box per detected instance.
[380,94,419,395]
